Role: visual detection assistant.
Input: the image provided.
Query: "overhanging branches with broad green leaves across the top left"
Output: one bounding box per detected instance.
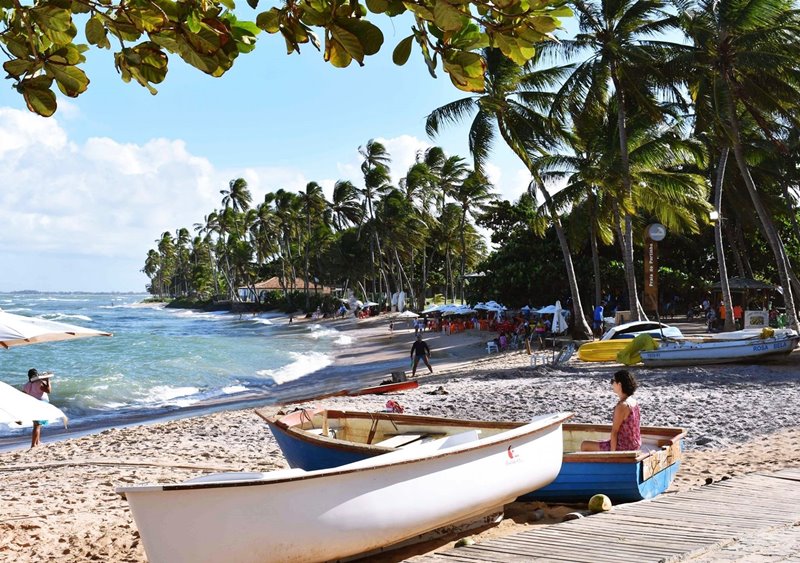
[0,0,571,116]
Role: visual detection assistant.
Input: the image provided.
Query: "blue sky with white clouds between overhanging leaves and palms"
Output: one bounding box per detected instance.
[0,11,529,292]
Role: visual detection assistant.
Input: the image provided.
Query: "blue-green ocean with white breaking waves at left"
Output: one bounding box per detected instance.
[0,293,374,446]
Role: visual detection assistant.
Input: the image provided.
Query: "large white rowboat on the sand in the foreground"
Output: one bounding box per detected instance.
[117,413,571,563]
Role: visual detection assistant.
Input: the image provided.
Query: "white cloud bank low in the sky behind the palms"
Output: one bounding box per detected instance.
[0,107,527,291]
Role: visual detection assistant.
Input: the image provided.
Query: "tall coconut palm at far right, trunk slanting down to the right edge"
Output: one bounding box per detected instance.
[673,0,800,328]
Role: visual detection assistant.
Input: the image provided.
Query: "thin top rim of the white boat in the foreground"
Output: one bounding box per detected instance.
[116,412,573,496]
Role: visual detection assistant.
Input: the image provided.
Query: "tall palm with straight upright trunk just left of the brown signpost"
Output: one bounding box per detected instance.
[543,0,676,320]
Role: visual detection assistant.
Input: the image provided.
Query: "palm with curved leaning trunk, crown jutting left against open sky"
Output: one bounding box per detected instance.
[426,49,591,338]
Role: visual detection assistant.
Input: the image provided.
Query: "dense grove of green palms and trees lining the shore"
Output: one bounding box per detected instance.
[138,0,800,330]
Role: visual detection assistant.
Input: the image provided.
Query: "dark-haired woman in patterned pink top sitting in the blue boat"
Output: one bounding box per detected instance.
[581,369,642,452]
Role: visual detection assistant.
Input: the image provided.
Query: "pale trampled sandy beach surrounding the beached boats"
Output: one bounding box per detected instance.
[0,317,800,562]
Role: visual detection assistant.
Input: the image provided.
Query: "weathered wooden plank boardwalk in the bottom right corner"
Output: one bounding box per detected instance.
[414,469,800,563]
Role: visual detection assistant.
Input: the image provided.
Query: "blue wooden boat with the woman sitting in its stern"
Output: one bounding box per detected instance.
[256,409,686,503]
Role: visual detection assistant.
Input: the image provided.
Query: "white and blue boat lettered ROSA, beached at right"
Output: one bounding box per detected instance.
[640,329,800,367]
